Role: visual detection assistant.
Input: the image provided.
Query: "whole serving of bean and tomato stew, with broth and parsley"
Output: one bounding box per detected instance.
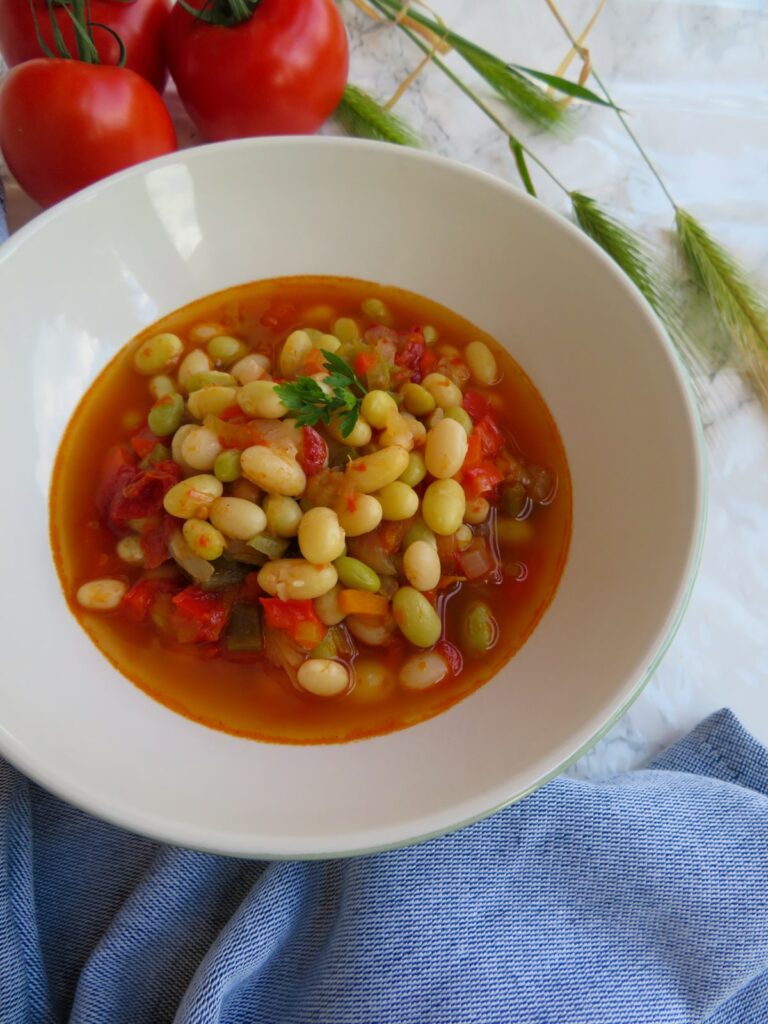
[53,279,570,740]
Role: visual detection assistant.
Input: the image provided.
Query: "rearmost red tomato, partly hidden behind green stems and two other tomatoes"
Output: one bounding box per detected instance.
[0,0,171,92]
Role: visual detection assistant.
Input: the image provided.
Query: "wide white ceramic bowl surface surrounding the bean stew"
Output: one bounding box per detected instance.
[0,138,702,857]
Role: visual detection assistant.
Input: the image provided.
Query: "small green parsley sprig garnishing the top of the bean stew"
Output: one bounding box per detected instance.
[274,352,368,437]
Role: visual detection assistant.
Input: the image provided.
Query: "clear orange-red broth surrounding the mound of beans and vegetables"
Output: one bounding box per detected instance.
[51,278,571,743]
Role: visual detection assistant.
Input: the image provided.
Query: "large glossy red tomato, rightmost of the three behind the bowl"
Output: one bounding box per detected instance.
[166,0,349,140]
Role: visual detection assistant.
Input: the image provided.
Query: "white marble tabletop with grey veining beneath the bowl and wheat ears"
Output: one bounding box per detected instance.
[1,0,768,776]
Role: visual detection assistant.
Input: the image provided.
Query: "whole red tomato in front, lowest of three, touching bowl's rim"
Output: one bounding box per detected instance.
[0,57,176,206]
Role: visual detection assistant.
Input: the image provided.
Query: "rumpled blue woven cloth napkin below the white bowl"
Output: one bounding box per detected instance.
[0,711,768,1024]
